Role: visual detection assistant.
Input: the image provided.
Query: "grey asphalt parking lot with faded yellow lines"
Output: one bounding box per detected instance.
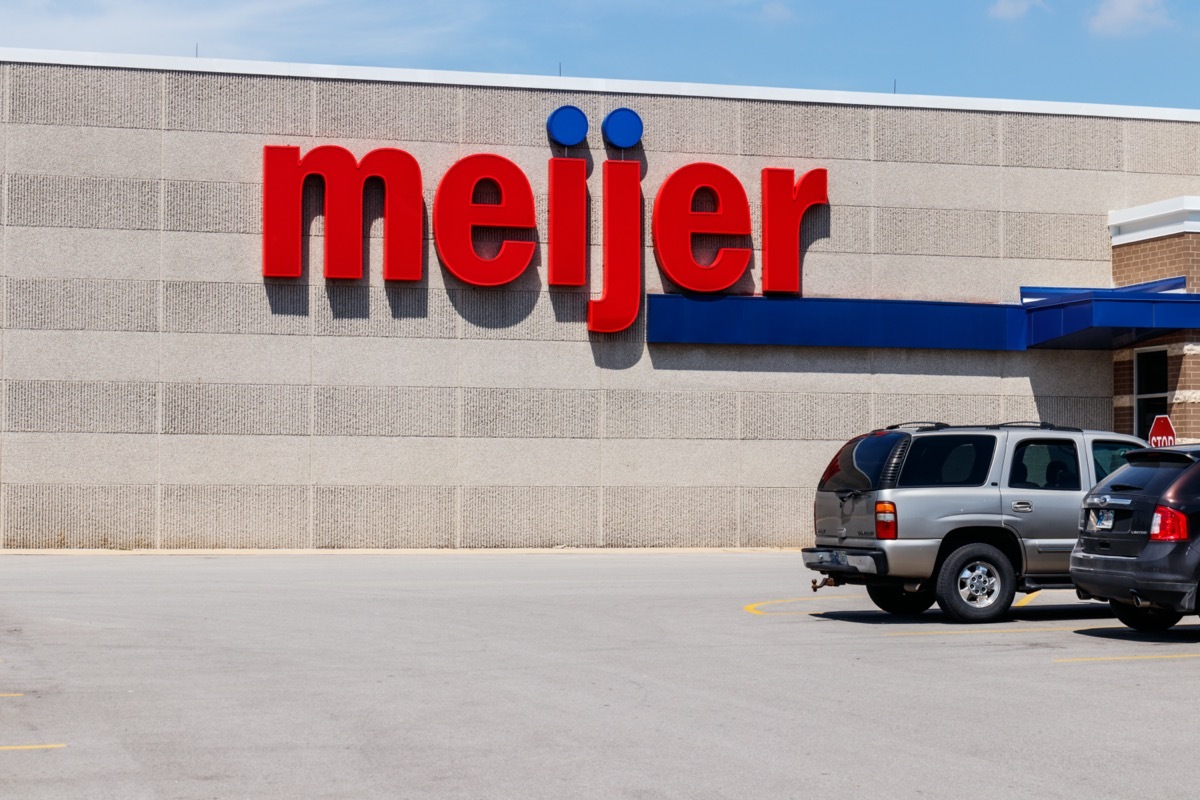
[0,552,1200,800]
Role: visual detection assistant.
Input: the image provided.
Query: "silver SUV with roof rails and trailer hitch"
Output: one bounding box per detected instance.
[803,422,1146,622]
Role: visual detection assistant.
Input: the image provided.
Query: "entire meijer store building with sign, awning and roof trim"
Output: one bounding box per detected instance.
[0,49,1200,548]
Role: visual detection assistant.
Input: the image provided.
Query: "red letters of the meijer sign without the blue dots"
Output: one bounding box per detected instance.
[263,145,829,332]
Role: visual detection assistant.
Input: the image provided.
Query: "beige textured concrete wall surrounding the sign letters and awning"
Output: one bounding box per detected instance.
[0,64,1200,548]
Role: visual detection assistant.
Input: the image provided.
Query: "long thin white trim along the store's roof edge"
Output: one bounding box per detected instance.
[7,47,1200,122]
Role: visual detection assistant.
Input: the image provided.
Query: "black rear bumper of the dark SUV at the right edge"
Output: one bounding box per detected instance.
[1070,542,1200,614]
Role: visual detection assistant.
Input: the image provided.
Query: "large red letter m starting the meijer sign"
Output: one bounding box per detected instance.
[263,145,424,281]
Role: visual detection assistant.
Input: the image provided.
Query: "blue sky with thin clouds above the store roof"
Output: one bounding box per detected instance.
[0,0,1200,108]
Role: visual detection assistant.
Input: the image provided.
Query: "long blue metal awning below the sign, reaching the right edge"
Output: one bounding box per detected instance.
[646,277,1200,350]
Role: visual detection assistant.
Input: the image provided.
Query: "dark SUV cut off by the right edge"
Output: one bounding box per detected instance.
[1070,445,1200,631]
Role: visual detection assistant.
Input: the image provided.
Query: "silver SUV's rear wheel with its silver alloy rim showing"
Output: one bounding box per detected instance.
[936,542,1016,622]
